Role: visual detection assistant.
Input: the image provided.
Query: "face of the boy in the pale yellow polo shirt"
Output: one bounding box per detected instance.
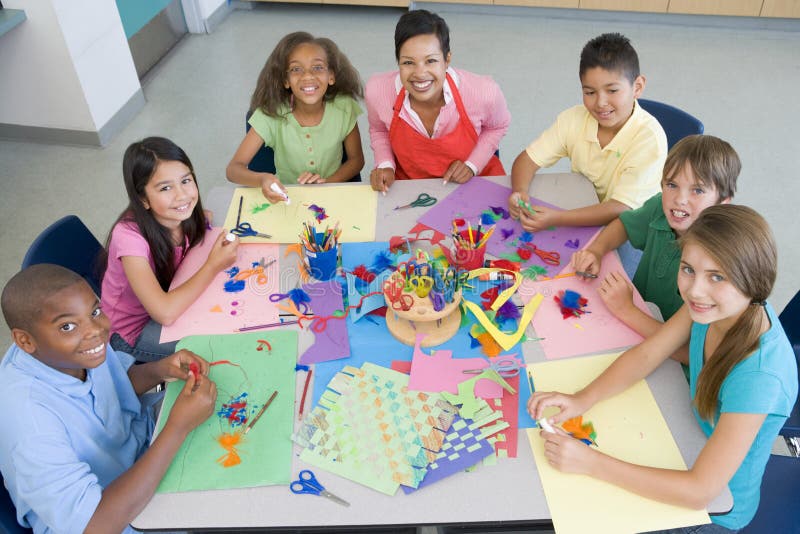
[581,67,645,134]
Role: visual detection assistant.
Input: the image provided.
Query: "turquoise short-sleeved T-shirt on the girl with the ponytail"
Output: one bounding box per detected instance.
[689,304,797,529]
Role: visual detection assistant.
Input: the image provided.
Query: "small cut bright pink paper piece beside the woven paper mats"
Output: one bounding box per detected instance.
[408,334,503,399]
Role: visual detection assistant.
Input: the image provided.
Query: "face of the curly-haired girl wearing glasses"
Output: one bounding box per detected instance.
[284,43,336,106]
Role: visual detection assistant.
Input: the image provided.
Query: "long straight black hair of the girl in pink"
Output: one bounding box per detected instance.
[102,137,206,291]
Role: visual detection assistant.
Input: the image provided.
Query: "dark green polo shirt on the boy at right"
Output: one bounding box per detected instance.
[619,193,683,321]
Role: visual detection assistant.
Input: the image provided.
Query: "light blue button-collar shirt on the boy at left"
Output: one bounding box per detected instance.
[0,345,153,534]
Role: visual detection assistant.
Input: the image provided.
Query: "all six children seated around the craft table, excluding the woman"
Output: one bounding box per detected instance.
[0,7,797,532]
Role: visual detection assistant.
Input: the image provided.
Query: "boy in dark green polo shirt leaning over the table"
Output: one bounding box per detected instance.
[571,135,742,363]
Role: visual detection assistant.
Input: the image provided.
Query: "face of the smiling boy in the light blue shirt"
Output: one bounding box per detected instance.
[13,281,110,380]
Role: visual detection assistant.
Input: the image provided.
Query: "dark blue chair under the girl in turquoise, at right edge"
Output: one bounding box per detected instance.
[740,292,800,534]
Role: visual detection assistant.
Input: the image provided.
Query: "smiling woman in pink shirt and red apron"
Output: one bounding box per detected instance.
[365,10,511,193]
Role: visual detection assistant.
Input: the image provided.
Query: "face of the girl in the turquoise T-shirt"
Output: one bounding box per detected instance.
[678,242,751,331]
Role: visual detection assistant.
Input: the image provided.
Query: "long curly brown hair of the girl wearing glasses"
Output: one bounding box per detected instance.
[250,32,364,117]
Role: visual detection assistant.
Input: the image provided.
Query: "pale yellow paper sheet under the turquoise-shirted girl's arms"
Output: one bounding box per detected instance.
[528,354,709,534]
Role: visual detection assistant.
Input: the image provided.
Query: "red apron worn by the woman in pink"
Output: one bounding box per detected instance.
[389,74,506,180]
